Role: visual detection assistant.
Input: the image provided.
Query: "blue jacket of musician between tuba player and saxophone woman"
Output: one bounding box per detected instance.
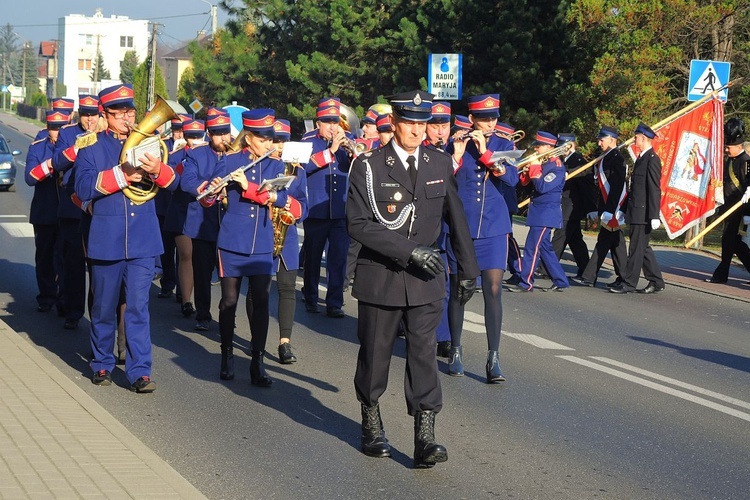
[180,144,225,241]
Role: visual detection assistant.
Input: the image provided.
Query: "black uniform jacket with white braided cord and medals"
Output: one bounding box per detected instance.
[346,142,479,306]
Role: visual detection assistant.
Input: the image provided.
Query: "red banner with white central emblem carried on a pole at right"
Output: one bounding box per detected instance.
[628,98,724,239]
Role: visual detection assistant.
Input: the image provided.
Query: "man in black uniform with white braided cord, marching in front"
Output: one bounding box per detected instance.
[346,91,479,468]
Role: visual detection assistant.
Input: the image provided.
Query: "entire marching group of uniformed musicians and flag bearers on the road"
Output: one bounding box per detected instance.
[20,85,750,467]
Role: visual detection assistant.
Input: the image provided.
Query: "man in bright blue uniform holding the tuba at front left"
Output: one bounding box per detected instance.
[75,85,176,393]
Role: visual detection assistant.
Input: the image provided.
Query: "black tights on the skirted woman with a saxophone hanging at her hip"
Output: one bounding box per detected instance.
[219,274,271,351]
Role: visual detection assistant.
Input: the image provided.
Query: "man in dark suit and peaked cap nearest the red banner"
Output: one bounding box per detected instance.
[609,123,664,293]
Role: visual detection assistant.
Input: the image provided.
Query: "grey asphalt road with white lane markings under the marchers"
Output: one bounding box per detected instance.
[0,122,750,499]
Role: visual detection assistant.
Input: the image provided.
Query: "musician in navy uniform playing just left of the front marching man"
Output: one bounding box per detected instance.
[302,98,351,318]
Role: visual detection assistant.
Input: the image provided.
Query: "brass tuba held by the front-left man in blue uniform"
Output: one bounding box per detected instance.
[120,96,184,205]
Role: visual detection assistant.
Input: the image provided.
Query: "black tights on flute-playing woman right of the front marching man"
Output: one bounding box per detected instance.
[448,269,505,351]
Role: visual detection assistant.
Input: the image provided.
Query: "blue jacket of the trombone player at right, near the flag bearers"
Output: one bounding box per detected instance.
[526,157,565,229]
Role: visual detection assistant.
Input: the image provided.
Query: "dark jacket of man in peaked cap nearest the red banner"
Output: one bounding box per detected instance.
[625,149,661,224]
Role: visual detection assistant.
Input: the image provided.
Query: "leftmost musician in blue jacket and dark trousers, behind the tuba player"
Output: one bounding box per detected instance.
[24,111,68,312]
